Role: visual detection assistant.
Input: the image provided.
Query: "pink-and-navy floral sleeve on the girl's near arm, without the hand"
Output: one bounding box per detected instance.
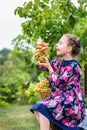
[48,64,81,88]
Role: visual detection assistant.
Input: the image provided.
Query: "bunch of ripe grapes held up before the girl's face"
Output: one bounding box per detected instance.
[35,38,49,63]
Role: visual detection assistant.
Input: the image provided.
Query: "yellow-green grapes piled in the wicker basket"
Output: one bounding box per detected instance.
[35,79,50,92]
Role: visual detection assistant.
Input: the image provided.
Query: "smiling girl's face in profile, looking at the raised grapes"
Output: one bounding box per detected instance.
[57,36,71,56]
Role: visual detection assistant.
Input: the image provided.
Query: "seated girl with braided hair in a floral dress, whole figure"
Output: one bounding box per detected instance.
[30,34,85,130]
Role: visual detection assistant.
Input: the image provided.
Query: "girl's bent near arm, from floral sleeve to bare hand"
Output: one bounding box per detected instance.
[39,60,80,87]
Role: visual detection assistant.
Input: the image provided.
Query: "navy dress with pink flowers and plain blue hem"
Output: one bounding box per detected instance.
[30,59,85,130]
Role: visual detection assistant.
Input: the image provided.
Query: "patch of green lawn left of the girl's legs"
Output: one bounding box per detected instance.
[0,105,39,130]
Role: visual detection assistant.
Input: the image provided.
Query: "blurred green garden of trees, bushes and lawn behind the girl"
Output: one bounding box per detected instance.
[0,0,87,130]
